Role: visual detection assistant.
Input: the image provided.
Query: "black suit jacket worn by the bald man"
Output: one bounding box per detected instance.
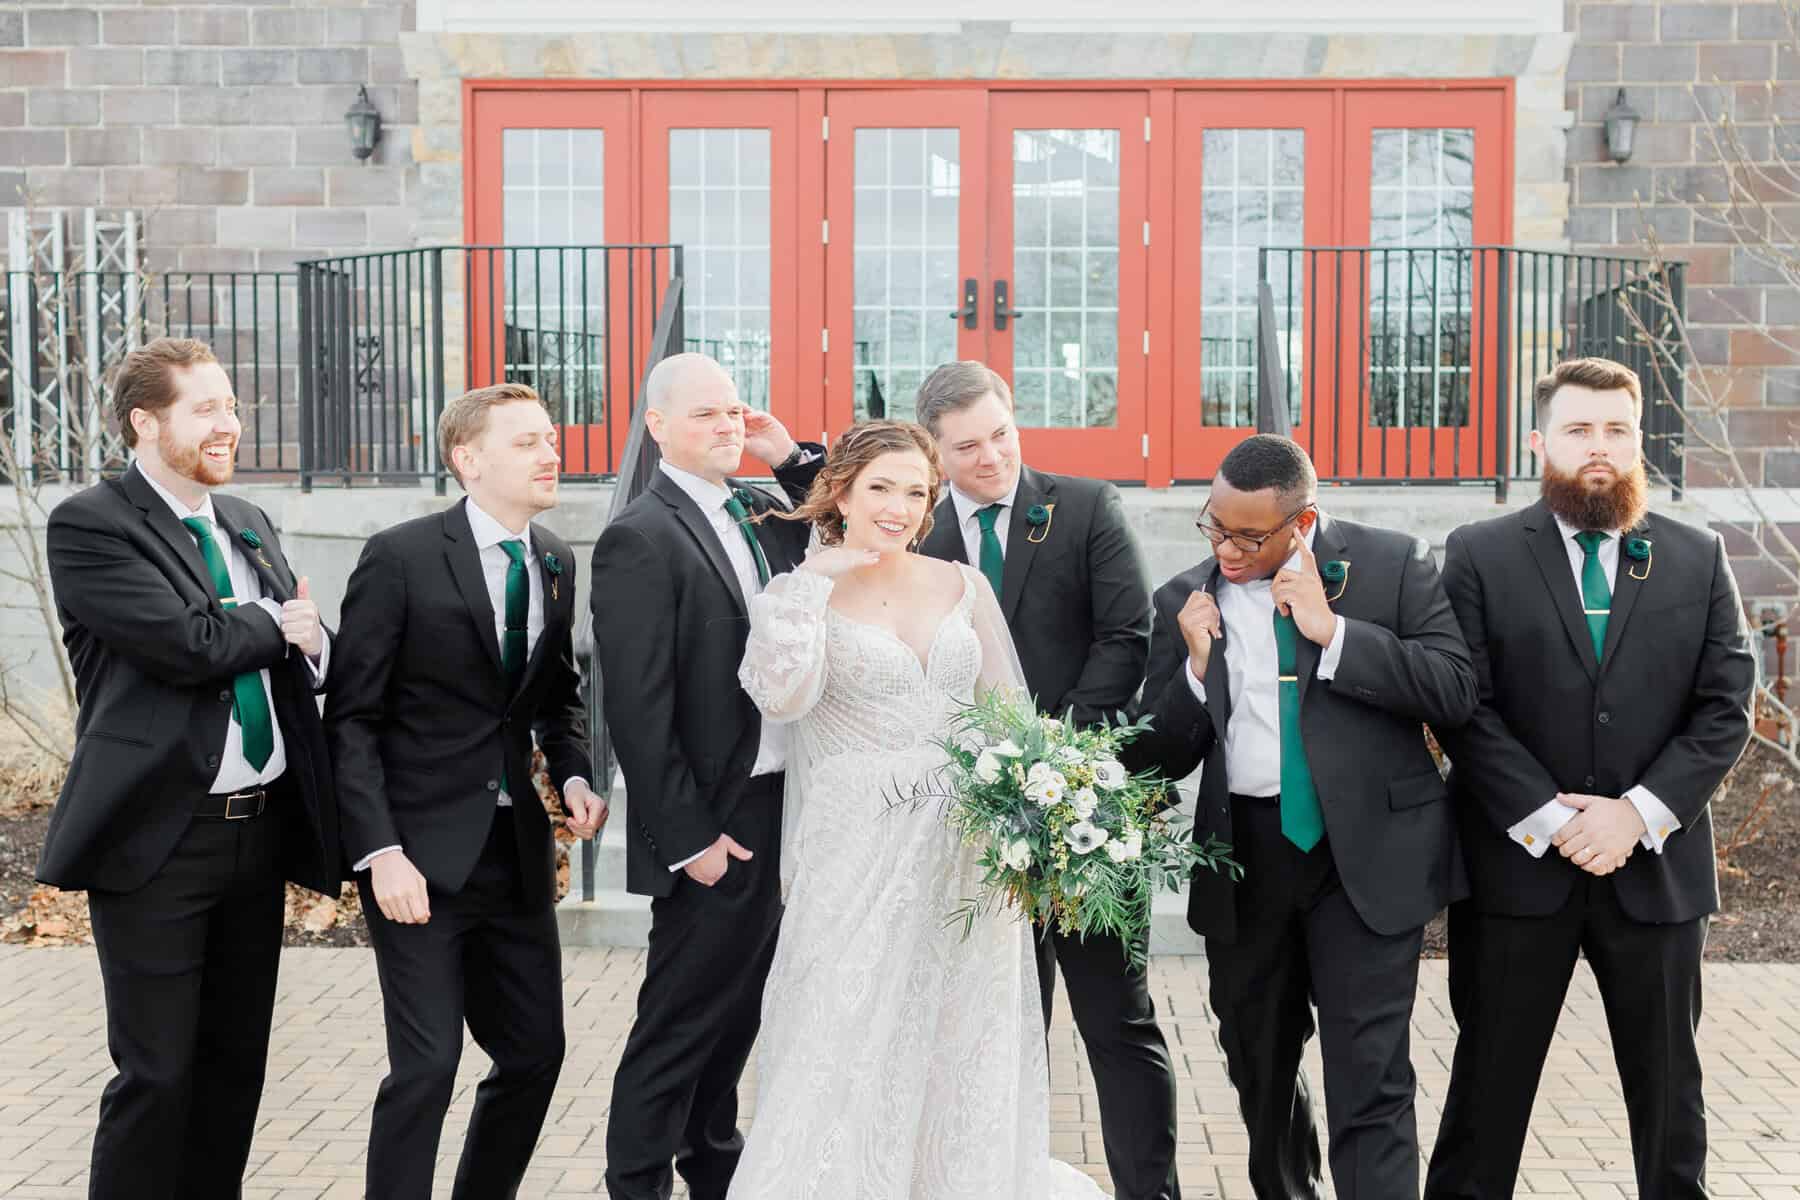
[592,455,823,896]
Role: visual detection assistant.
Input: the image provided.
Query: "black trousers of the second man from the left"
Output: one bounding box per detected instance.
[358,806,563,1200]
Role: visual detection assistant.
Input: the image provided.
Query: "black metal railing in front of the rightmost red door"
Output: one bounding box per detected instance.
[1260,246,1683,498]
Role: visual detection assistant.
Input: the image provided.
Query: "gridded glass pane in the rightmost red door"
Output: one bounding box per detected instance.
[1368,130,1474,428]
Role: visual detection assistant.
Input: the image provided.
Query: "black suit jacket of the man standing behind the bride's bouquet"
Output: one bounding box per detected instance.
[920,468,1150,725]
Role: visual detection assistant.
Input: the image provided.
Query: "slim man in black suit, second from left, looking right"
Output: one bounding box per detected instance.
[326,383,605,1200]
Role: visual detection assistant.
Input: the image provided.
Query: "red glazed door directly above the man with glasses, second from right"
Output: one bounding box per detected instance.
[1166,90,1337,479]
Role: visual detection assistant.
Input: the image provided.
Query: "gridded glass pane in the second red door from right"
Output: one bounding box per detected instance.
[1199,130,1307,426]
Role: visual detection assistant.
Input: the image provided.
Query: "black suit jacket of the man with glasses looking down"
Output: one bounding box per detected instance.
[1127,516,1476,945]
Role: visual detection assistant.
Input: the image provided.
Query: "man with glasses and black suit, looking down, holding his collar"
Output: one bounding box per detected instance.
[1129,434,1474,1200]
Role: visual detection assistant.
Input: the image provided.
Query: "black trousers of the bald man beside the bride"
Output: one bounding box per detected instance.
[607,774,781,1200]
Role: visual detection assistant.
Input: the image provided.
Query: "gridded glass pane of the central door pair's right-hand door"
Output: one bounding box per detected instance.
[1008,130,1136,428]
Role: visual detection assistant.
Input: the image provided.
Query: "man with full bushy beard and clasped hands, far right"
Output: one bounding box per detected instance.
[1426,358,1757,1200]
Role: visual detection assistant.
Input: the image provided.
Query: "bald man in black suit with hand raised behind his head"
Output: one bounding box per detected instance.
[594,354,824,1200]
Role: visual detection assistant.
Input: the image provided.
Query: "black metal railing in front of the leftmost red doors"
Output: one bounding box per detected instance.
[299,245,682,491]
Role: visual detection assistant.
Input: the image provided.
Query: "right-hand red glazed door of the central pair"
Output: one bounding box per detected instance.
[983,92,1148,479]
